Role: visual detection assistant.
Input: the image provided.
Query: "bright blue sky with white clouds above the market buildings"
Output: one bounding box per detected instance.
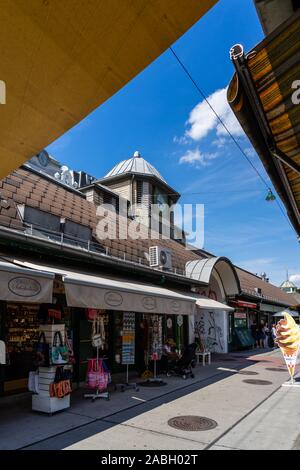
[48,0,300,285]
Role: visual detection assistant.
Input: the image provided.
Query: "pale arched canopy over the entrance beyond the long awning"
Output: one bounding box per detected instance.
[185,257,241,296]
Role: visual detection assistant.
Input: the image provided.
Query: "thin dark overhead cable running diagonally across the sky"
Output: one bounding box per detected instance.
[169,46,294,230]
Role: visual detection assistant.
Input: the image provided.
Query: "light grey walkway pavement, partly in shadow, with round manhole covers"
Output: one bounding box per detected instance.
[0,350,300,450]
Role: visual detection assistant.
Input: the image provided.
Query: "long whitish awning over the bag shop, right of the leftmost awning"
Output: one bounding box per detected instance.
[18,261,196,315]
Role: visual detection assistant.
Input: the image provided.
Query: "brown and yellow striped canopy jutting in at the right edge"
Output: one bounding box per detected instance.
[228,12,300,235]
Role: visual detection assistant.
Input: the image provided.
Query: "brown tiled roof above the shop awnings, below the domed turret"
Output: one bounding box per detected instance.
[0,168,203,272]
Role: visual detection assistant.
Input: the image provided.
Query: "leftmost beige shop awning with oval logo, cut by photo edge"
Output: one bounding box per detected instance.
[0,261,54,303]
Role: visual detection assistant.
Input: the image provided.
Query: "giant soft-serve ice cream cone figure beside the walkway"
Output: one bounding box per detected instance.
[276,312,300,382]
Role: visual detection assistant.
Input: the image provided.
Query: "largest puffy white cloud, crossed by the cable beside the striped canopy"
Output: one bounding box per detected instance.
[186,88,244,141]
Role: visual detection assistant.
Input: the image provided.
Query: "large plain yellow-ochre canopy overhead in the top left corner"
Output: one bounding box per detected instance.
[0,0,217,178]
